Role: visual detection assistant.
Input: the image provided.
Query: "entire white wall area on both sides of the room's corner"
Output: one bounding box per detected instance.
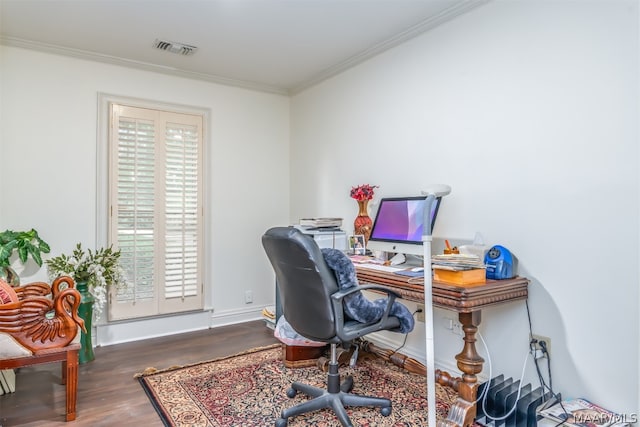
[0,0,640,418]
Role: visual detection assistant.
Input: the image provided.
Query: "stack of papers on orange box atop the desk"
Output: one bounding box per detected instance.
[431,254,487,285]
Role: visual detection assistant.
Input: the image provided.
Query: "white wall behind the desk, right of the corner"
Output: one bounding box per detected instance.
[291,0,640,413]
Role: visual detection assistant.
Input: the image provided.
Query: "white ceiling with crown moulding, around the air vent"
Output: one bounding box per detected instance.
[0,0,488,94]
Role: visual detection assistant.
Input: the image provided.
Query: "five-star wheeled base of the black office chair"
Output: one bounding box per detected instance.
[276,354,391,427]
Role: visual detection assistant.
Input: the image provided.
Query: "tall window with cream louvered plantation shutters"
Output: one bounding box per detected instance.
[109,103,204,320]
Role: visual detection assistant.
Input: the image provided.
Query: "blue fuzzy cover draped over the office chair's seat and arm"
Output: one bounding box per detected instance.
[321,248,415,334]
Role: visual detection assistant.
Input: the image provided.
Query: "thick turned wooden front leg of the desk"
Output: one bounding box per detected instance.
[438,311,484,427]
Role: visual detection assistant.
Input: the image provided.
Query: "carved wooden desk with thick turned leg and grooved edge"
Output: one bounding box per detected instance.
[356,264,529,427]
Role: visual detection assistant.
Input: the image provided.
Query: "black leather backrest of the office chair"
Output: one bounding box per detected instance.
[262,227,340,342]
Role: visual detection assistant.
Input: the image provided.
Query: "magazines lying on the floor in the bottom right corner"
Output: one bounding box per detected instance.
[538,399,638,427]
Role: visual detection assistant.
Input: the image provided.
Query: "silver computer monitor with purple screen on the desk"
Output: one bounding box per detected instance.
[367,196,442,256]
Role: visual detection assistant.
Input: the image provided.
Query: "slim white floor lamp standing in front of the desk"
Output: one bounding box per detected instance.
[422,184,451,427]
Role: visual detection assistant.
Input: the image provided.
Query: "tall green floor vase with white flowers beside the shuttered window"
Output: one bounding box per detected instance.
[46,243,127,363]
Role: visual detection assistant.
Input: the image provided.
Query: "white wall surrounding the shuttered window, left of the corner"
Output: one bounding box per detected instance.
[0,46,289,344]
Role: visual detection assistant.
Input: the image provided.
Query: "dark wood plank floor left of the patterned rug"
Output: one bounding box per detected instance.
[0,320,278,427]
